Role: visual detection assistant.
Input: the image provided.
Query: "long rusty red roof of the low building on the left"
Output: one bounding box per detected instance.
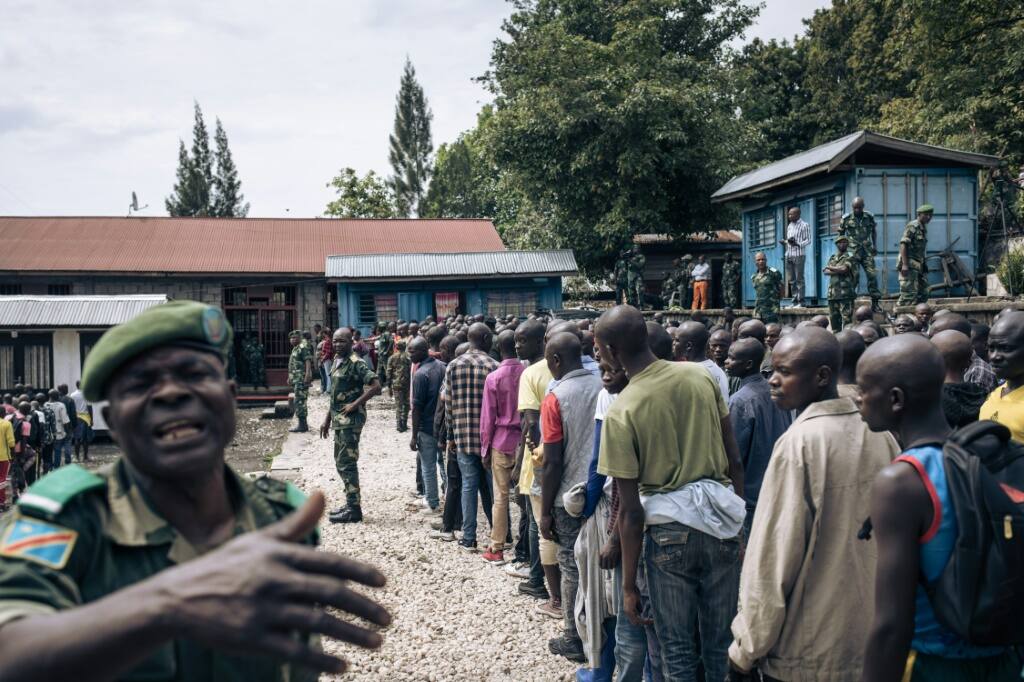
[0,217,505,276]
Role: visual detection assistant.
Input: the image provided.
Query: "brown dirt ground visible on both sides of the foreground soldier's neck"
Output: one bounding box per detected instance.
[79,408,295,473]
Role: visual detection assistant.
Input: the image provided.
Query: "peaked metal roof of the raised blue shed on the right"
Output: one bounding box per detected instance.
[712,130,999,202]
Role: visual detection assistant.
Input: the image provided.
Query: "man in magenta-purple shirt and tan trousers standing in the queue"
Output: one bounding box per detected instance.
[480,330,525,564]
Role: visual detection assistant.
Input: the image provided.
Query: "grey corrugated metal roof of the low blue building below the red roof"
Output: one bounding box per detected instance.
[327,249,578,281]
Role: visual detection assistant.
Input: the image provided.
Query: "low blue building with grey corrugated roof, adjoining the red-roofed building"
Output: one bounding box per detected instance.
[327,250,577,334]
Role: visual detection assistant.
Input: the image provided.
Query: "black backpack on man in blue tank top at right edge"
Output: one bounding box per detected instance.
[926,421,1024,646]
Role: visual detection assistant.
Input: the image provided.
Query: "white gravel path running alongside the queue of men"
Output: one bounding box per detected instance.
[285,395,575,681]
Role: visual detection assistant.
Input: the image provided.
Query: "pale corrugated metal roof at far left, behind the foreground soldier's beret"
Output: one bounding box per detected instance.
[0,294,167,329]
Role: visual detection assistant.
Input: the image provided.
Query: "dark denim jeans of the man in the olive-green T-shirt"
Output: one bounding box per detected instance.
[643,523,740,682]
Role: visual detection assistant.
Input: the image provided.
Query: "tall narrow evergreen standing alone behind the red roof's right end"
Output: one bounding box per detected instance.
[388,57,433,216]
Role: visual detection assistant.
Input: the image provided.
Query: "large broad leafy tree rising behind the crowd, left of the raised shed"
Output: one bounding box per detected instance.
[483,0,756,272]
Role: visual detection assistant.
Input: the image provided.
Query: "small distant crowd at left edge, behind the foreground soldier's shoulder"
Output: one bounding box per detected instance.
[0,382,92,512]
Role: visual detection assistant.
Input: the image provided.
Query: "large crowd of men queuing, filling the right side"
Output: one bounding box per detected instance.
[325,304,1024,682]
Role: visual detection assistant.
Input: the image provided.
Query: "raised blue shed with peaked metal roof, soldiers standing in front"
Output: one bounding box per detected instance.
[712,130,999,305]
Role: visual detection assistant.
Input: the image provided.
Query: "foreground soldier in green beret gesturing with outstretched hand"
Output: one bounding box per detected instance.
[0,301,389,682]
